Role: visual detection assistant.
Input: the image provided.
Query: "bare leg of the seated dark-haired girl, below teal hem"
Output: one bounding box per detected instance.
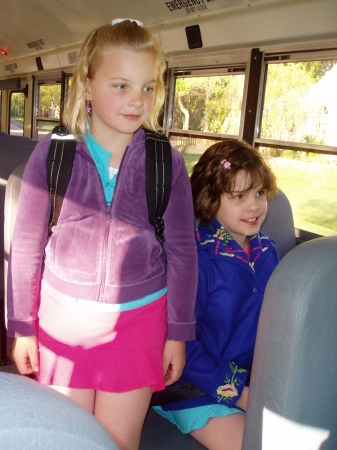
[191,414,245,450]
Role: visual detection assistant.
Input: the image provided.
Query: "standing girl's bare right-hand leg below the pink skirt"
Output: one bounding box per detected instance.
[94,387,152,450]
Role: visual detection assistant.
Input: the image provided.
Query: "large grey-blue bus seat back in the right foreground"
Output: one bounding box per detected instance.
[243,236,337,450]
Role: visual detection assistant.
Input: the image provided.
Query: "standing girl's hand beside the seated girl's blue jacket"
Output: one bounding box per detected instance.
[163,341,186,386]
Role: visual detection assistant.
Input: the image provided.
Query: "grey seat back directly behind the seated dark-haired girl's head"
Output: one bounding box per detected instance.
[261,190,296,259]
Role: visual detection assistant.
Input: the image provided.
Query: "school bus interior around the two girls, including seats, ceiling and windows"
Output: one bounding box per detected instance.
[0,0,337,450]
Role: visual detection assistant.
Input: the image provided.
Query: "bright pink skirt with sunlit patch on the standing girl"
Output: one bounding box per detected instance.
[36,281,167,392]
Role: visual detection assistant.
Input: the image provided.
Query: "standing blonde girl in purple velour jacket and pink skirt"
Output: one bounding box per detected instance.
[8,19,197,450]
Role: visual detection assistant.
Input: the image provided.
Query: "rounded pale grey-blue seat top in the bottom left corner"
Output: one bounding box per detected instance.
[0,372,118,450]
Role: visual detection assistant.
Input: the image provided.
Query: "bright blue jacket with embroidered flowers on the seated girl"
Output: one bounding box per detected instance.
[163,218,279,410]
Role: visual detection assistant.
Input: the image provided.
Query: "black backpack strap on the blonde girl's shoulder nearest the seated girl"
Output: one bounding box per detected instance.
[145,129,172,245]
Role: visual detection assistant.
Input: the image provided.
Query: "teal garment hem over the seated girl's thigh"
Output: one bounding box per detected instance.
[153,405,245,434]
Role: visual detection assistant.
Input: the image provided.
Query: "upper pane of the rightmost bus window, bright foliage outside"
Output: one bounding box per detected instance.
[260,60,337,146]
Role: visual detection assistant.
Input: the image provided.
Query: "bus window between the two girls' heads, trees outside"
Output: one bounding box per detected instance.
[169,67,245,173]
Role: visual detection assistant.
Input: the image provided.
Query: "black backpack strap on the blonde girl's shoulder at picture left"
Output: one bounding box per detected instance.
[47,125,76,234]
